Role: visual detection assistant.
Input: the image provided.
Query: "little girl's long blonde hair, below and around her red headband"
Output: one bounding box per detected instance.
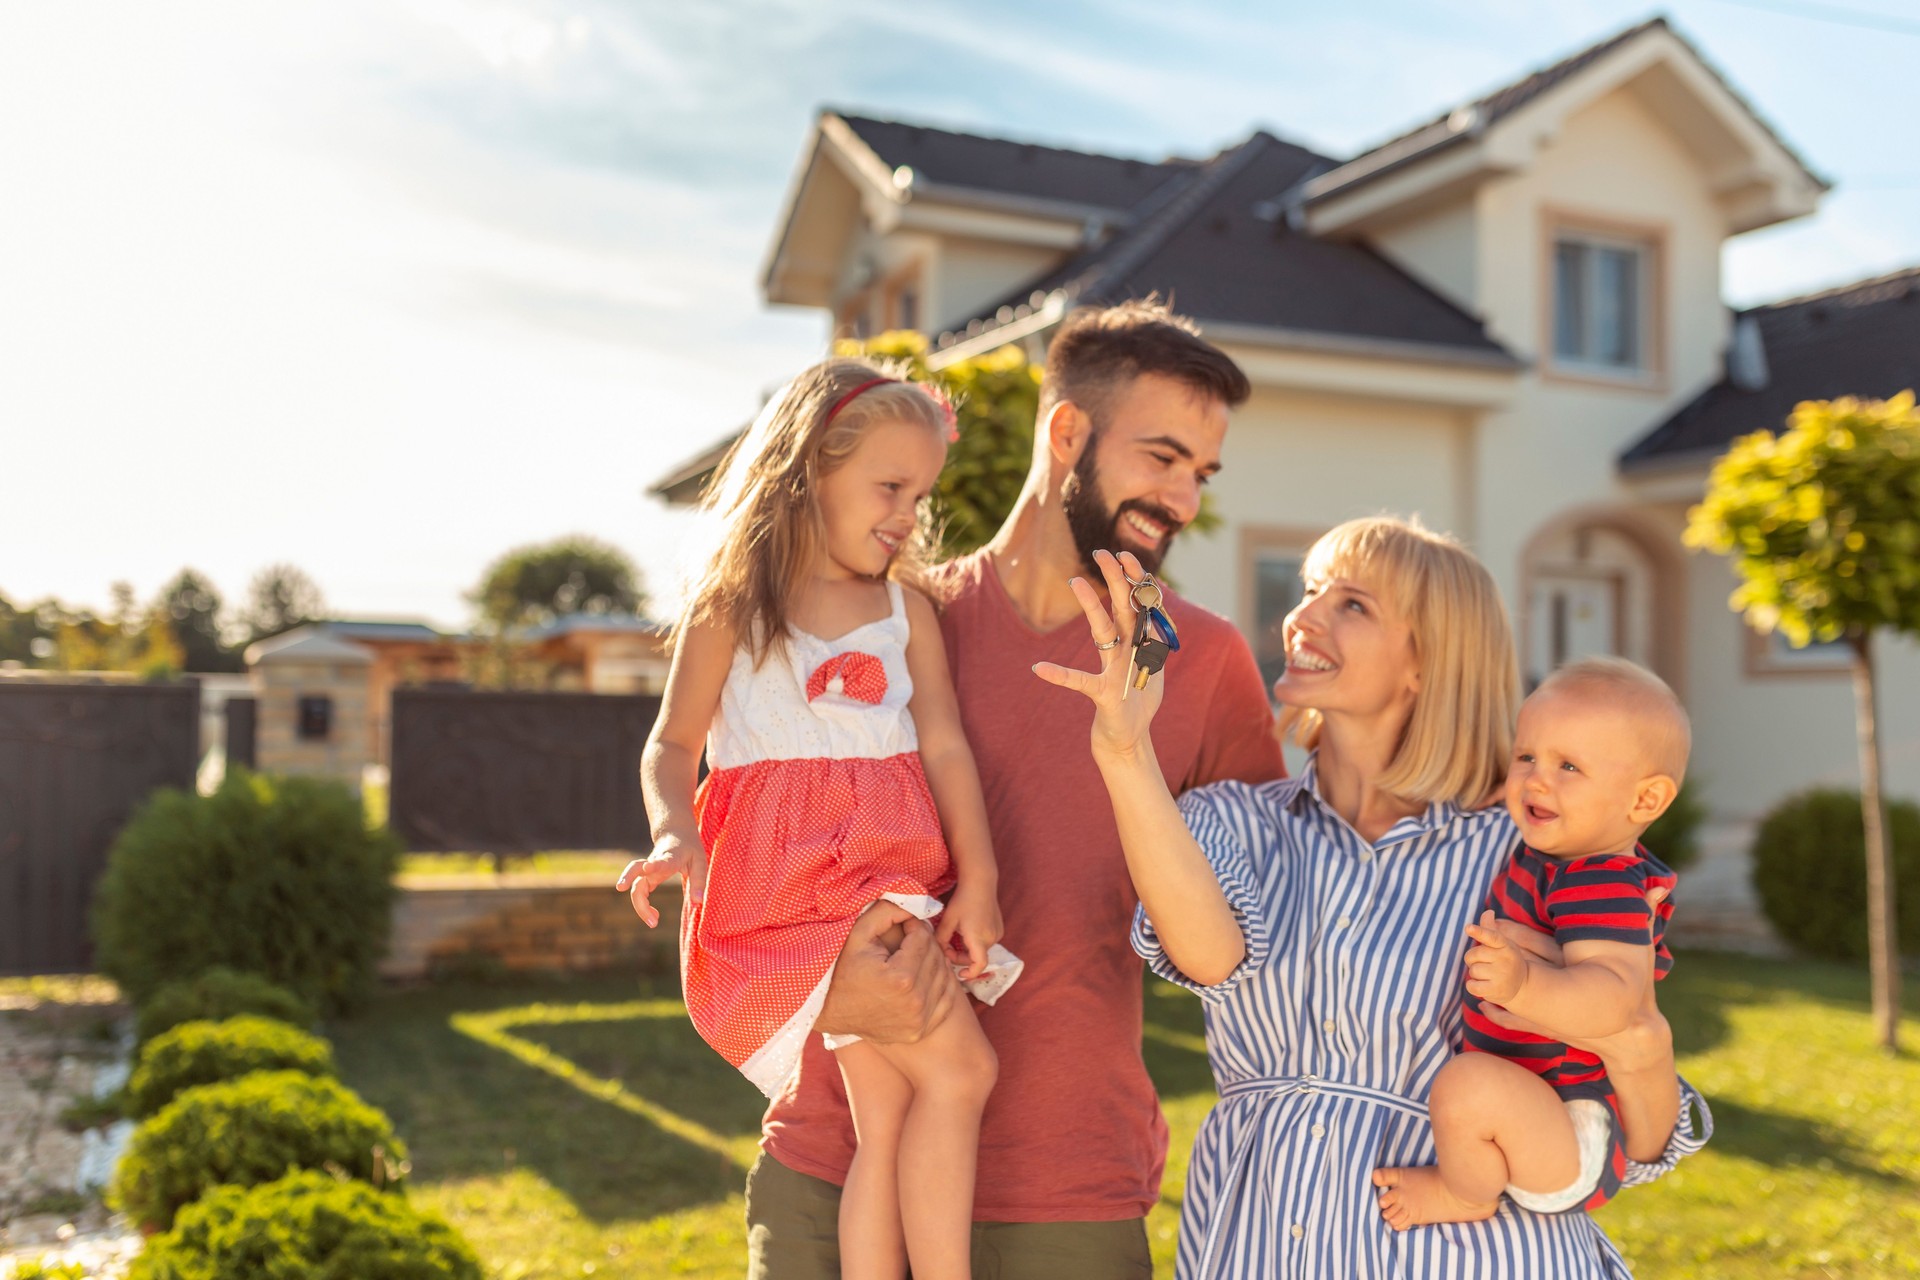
[680,357,948,664]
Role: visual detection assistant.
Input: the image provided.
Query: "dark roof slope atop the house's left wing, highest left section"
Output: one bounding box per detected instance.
[831,111,1196,213]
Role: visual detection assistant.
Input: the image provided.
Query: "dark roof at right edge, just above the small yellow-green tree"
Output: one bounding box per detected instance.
[1620,267,1920,470]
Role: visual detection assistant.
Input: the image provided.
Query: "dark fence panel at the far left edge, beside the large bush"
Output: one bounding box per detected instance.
[0,679,200,973]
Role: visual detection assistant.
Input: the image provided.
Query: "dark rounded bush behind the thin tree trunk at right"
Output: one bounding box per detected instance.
[1753,791,1920,960]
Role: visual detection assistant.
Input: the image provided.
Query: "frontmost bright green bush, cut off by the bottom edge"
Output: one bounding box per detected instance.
[129,1173,480,1280]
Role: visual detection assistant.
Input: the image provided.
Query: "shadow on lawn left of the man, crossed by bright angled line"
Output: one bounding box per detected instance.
[330,979,762,1222]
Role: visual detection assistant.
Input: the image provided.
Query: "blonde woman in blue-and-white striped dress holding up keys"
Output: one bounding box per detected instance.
[1035,520,1711,1280]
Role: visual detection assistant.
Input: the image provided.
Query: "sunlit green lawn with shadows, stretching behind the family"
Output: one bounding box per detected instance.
[326,954,1920,1280]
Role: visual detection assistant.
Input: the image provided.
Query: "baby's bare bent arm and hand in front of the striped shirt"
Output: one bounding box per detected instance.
[1467,912,1653,1040]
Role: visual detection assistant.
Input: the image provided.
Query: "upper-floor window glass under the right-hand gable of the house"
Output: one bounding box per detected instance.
[1553,230,1653,374]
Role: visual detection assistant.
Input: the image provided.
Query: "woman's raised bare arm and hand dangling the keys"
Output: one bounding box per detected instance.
[1033,551,1246,986]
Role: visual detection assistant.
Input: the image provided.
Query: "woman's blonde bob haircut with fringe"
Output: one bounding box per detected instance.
[1281,516,1519,808]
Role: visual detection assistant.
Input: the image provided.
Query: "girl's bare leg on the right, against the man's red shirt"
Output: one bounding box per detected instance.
[867,1000,1000,1280]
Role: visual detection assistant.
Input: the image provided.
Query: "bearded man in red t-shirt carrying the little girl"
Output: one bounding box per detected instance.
[747,303,1283,1280]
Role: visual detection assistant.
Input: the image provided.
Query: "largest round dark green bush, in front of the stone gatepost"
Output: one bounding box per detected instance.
[94,770,399,1011]
